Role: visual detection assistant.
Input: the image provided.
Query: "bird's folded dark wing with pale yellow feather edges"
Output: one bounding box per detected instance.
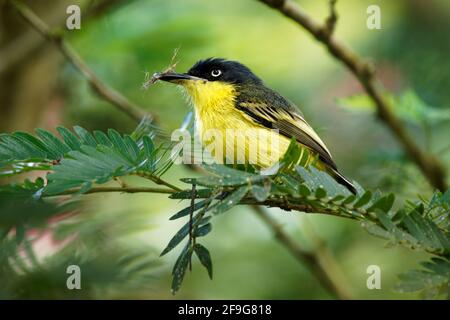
[236,87,337,170]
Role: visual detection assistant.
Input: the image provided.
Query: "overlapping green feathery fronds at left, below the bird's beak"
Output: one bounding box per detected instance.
[0,126,166,195]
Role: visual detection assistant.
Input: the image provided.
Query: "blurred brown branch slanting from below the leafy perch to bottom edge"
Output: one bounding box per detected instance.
[252,206,350,300]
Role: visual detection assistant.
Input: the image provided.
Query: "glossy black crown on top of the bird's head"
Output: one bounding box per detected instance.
[188,58,262,84]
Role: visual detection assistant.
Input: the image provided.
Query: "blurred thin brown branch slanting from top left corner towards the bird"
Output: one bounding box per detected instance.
[9,0,153,121]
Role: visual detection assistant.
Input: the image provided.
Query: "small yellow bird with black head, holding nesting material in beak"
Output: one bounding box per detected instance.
[156,58,356,194]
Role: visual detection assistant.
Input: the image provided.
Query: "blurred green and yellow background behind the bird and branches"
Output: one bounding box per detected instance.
[0,0,450,299]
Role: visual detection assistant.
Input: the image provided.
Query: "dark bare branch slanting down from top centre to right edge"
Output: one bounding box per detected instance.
[259,0,446,191]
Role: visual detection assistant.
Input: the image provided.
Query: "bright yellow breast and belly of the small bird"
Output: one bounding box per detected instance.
[184,80,298,168]
